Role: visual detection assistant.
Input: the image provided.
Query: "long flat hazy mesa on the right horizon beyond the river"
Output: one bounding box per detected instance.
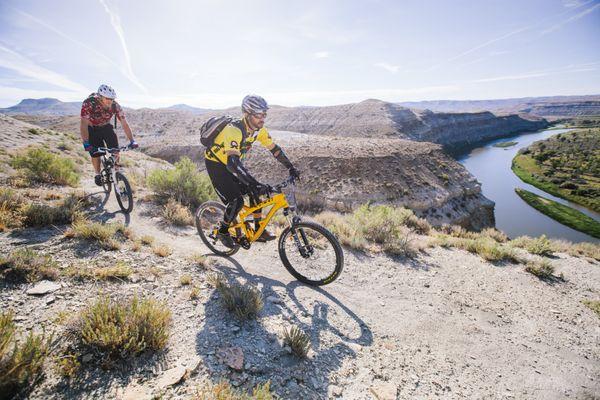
[397,95,600,117]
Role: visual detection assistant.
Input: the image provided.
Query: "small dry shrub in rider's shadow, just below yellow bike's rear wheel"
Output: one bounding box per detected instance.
[209,274,264,320]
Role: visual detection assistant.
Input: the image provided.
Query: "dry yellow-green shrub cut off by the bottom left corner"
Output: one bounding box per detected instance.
[0,312,52,399]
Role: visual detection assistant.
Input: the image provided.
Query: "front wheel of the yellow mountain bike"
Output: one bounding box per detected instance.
[279,222,344,286]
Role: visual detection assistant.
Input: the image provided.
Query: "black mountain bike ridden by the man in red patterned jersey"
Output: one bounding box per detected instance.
[96,146,133,214]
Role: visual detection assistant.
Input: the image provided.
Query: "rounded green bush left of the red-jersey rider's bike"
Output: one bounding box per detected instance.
[11,148,79,186]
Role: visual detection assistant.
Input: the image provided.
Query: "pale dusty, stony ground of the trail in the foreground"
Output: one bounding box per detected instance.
[0,170,600,399]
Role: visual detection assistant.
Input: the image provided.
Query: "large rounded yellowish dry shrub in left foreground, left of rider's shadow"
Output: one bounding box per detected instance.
[75,296,171,359]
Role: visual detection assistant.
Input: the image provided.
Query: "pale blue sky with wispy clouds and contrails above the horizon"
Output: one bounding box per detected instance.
[0,0,600,108]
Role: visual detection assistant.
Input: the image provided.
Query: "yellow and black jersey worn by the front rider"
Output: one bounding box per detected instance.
[204,122,274,164]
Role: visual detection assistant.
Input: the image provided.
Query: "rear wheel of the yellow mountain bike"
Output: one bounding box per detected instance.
[196,201,240,256]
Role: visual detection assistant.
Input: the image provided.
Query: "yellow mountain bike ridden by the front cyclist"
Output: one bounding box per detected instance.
[196,177,344,286]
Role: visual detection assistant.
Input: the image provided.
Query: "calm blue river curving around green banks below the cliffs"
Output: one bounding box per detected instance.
[457,129,600,243]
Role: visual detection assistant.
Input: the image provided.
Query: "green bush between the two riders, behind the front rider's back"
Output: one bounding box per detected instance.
[147,157,216,208]
